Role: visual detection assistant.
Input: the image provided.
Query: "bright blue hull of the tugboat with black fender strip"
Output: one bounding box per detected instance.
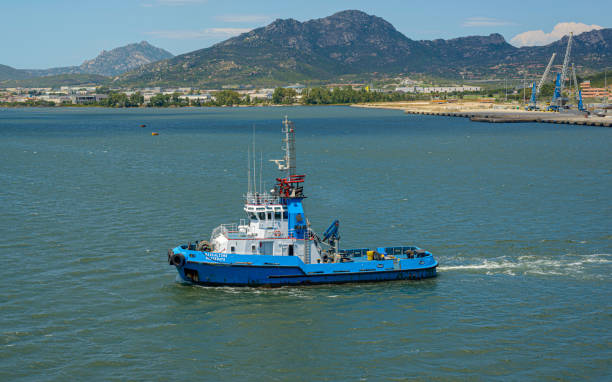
[176,249,438,286]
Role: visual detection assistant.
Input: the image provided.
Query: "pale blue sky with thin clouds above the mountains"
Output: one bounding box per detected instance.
[0,0,612,69]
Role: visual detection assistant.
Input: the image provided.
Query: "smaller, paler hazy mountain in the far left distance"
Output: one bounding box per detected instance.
[0,41,174,81]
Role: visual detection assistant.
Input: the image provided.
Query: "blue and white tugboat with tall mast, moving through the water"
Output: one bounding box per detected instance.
[168,117,438,286]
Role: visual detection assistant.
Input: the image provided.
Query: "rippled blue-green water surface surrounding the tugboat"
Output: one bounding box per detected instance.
[0,107,612,381]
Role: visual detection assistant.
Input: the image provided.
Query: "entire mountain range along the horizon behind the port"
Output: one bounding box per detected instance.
[0,10,612,87]
